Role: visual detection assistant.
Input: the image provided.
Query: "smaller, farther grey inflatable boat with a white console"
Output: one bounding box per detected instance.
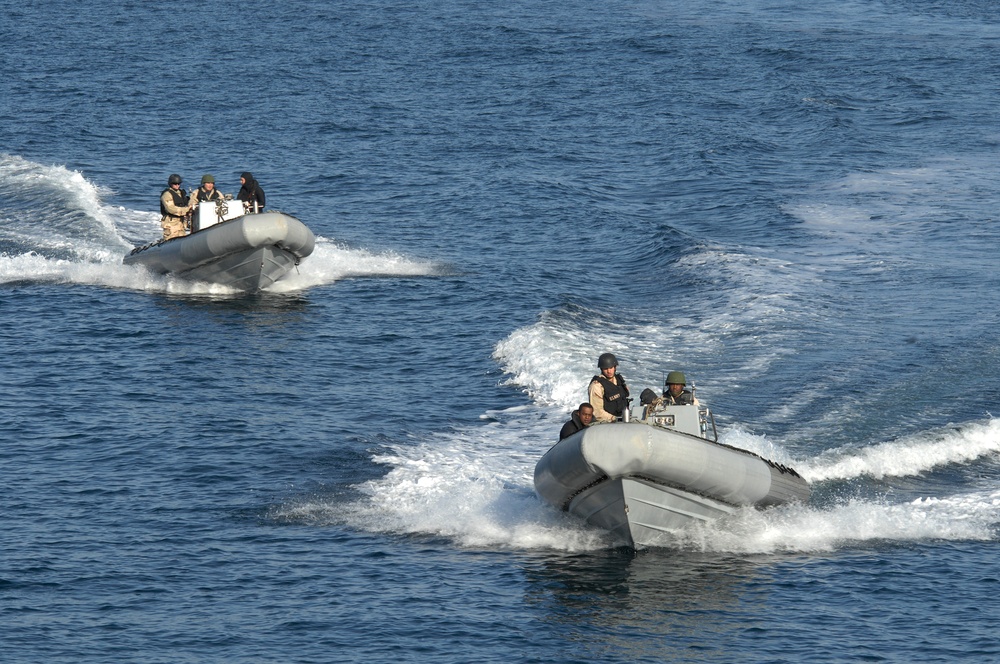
[124,201,316,292]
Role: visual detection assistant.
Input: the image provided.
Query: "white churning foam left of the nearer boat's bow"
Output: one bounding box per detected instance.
[273,408,609,551]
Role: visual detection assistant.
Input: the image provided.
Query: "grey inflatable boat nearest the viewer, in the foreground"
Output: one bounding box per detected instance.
[535,396,810,548]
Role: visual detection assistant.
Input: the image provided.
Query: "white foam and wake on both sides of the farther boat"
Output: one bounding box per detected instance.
[0,154,444,295]
